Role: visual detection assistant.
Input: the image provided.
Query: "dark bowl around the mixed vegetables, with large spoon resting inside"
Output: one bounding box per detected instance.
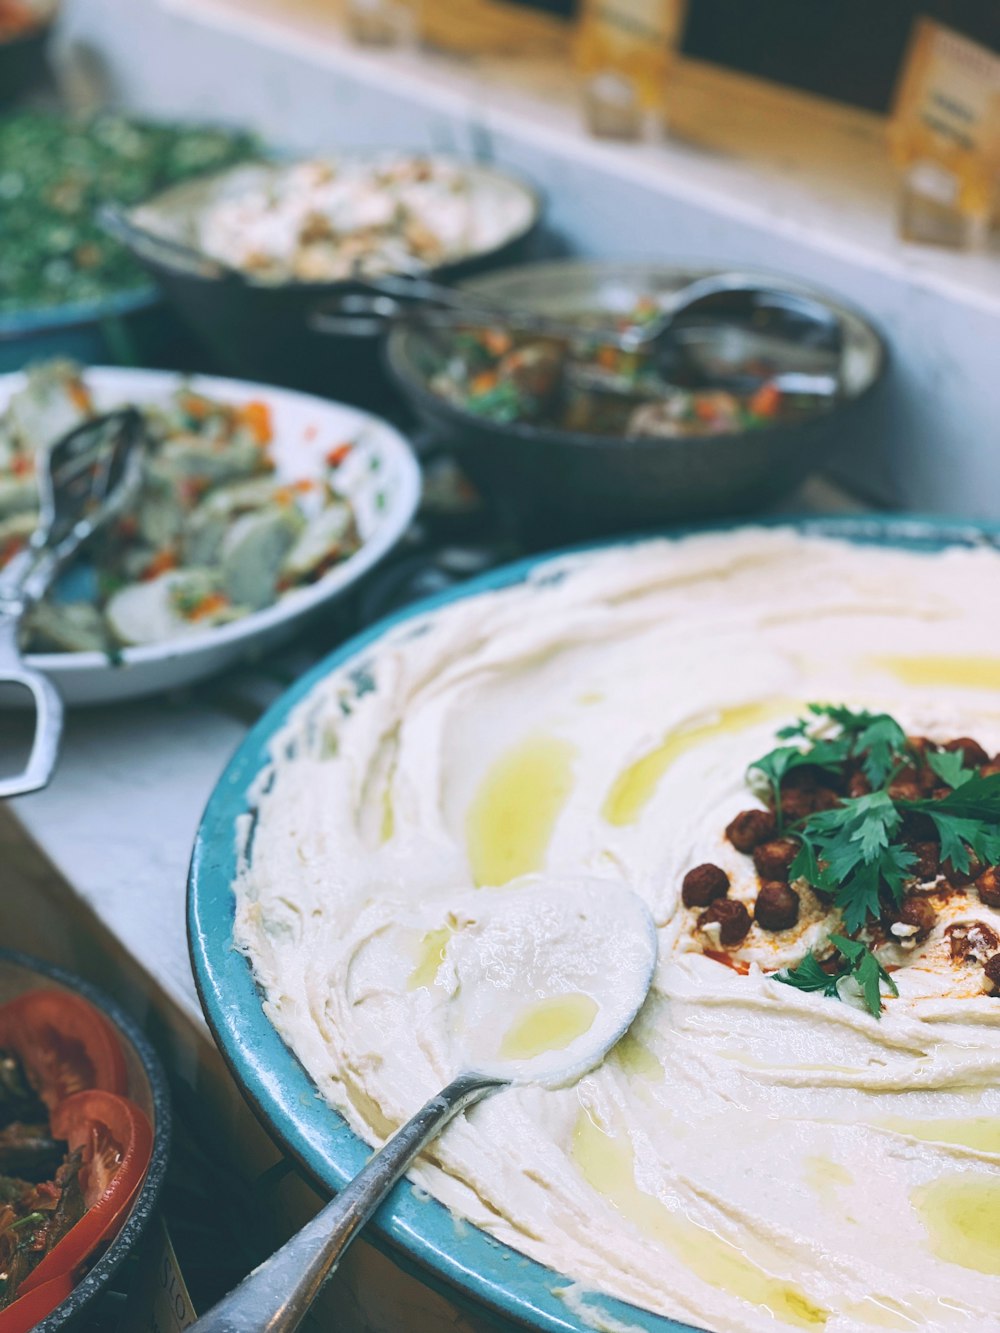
[385,260,885,540]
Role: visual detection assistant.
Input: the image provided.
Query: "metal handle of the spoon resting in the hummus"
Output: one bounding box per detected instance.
[185,1074,507,1333]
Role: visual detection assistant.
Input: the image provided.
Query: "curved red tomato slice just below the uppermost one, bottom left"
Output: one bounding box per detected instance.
[11,1089,153,1309]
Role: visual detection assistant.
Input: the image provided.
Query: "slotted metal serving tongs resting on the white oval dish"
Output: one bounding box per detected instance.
[0,408,145,798]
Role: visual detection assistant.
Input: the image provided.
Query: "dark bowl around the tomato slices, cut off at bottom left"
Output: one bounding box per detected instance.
[0,949,171,1333]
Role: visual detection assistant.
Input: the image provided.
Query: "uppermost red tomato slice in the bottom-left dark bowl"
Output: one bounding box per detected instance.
[0,990,128,1110]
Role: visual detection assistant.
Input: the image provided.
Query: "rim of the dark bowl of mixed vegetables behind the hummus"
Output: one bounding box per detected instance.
[383,259,889,453]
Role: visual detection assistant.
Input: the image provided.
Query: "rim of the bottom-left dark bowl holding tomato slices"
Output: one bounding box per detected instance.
[0,948,172,1333]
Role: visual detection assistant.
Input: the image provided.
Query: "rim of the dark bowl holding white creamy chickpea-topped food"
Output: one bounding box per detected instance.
[117,144,547,300]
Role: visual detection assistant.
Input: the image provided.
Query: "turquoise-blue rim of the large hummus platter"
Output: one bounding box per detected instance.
[188,515,1000,1333]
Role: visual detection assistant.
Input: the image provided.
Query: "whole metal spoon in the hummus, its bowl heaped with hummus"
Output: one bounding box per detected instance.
[192,876,657,1333]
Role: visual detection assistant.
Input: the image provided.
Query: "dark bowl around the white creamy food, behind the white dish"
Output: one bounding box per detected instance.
[117,153,543,409]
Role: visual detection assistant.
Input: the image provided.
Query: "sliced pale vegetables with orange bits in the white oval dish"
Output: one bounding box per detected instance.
[0,363,360,653]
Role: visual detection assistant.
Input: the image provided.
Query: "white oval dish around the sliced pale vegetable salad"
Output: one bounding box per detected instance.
[0,367,420,705]
